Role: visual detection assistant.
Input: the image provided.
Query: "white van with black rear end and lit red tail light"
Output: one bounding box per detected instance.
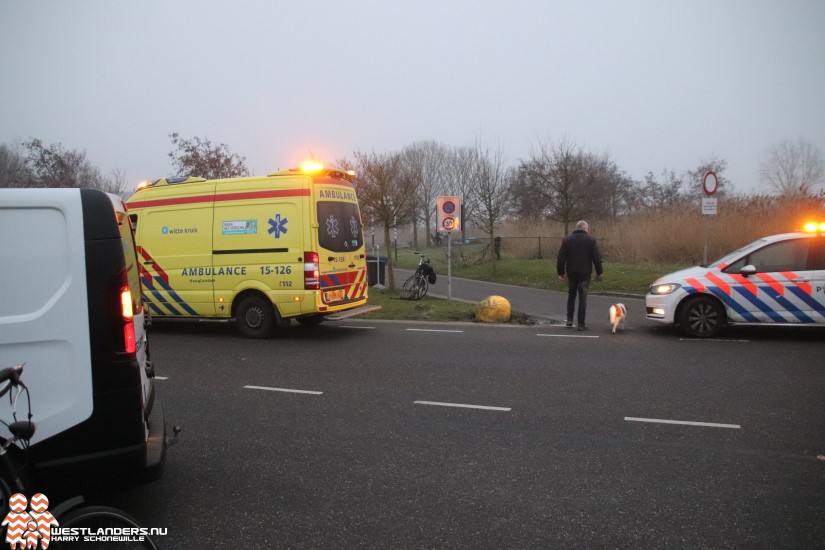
[0,189,166,488]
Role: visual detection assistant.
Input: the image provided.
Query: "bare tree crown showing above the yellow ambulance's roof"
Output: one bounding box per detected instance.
[169,132,249,179]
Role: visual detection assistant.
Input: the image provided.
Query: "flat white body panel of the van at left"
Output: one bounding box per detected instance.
[0,189,93,444]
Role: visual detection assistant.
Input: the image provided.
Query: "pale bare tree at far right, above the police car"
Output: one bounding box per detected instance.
[760,138,825,197]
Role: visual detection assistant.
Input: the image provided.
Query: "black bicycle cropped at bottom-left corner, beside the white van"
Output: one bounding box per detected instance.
[0,363,157,550]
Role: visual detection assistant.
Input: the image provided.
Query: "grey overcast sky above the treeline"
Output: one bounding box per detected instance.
[0,0,825,192]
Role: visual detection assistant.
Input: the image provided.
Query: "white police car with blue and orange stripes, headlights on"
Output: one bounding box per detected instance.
[645,223,825,338]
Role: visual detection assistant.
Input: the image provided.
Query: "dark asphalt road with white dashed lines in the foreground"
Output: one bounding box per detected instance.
[96,310,825,549]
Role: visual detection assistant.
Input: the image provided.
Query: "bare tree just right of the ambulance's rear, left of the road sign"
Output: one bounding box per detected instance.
[353,151,416,288]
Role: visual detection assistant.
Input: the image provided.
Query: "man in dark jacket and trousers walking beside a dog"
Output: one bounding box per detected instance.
[556,220,602,330]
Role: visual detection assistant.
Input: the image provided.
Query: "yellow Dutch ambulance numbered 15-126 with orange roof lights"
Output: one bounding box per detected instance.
[126,166,368,338]
